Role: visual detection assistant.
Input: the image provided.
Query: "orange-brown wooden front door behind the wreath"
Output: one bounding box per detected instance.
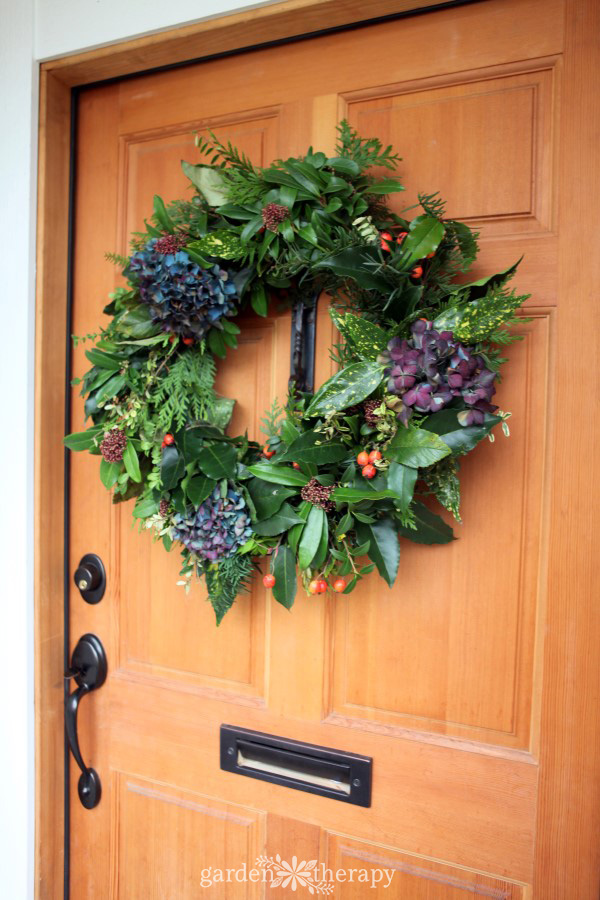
[70,0,598,900]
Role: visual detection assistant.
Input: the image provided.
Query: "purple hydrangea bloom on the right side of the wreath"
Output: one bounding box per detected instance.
[381,319,498,425]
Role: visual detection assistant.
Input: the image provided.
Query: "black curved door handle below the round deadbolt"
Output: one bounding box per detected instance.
[65,634,108,809]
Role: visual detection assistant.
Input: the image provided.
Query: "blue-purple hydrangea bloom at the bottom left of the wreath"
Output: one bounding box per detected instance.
[173,487,252,562]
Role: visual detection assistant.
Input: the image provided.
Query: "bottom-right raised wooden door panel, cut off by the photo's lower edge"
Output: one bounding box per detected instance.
[324,833,529,900]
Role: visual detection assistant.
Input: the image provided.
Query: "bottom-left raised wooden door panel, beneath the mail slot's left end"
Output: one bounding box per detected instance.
[109,773,264,900]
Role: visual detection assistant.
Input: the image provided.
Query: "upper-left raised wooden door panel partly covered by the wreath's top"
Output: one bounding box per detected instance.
[119,111,279,252]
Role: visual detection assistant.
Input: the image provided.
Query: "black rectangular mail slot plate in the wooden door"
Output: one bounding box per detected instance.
[221,725,373,806]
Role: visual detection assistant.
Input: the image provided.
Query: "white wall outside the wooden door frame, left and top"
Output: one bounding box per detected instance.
[0,0,271,900]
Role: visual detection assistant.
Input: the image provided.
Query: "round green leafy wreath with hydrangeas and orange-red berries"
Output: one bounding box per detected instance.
[65,122,527,624]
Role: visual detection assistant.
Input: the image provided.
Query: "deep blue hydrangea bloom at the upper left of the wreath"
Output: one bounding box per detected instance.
[129,238,239,340]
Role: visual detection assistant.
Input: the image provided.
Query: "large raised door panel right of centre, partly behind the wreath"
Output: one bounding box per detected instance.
[330,311,550,749]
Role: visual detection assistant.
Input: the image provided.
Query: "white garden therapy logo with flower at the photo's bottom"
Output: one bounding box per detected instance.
[200,853,394,896]
